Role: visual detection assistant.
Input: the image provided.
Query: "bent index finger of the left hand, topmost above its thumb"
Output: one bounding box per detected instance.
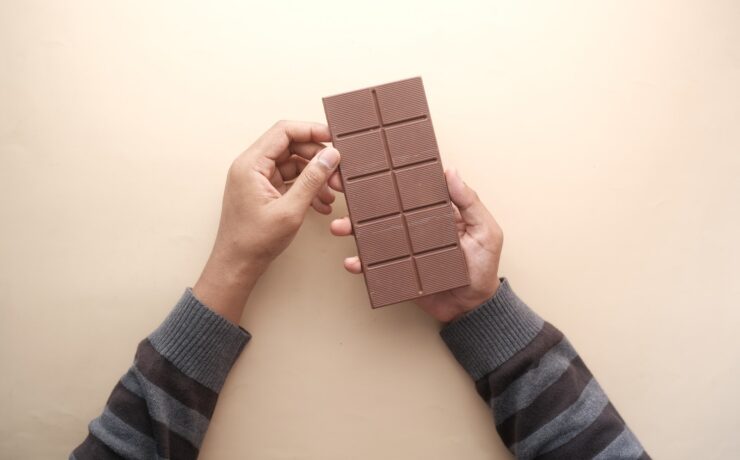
[252,120,331,161]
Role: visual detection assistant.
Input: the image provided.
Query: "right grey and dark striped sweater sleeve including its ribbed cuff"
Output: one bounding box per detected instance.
[440,279,650,460]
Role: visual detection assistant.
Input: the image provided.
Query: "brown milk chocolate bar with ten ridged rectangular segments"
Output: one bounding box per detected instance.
[324,78,470,308]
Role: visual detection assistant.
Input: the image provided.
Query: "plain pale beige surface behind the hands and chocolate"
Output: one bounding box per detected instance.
[0,0,740,459]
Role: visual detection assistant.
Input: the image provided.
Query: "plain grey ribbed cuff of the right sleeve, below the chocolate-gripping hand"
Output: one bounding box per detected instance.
[440,278,544,381]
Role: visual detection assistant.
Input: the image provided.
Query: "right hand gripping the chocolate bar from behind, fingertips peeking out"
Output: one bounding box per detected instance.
[329,170,504,322]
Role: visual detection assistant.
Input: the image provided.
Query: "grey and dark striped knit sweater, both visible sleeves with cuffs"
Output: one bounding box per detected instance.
[70,279,650,460]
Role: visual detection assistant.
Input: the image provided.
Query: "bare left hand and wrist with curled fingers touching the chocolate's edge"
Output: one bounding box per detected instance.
[193,121,339,323]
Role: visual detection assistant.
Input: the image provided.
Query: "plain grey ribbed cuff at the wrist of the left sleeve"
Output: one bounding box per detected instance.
[149,288,251,393]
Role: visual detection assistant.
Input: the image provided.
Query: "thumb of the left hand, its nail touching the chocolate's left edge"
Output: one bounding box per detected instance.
[283,147,339,212]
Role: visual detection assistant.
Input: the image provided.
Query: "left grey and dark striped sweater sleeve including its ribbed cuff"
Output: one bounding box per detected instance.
[70,289,250,460]
